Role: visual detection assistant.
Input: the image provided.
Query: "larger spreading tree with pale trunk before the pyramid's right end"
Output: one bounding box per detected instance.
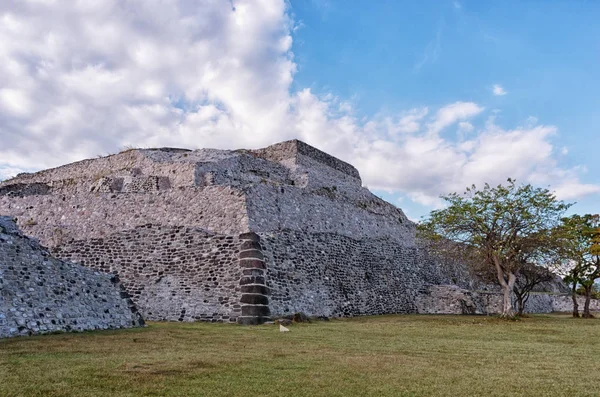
[419,179,570,317]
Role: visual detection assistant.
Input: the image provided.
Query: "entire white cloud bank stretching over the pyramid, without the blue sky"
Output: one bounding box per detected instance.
[0,0,599,207]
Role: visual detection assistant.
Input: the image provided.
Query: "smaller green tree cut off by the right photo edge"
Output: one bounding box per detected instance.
[558,214,600,318]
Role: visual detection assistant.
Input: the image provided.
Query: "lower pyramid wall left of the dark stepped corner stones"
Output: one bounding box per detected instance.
[53,224,242,322]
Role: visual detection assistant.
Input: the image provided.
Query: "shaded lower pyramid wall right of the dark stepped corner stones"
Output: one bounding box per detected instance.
[259,230,462,316]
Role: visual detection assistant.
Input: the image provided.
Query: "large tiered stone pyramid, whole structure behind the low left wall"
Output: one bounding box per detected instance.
[0,140,572,324]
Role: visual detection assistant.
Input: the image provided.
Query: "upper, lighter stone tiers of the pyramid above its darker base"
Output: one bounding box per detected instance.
[0,141,414,246]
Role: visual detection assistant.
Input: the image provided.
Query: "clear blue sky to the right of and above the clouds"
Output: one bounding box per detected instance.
[291,0,600,217]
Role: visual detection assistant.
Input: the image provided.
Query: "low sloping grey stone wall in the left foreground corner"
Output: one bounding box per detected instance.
[0,217,144,338]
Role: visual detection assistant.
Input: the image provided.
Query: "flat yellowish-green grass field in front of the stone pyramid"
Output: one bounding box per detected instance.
[0,315,600,397]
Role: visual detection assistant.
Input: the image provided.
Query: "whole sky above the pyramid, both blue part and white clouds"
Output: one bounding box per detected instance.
[0,0,600,219]
